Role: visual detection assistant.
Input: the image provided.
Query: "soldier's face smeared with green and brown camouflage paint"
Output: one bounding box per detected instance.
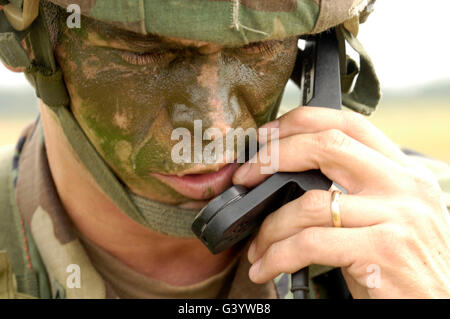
[56,19,297,206]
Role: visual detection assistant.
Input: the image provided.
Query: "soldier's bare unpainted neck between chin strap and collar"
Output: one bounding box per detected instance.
[41,104,236,286]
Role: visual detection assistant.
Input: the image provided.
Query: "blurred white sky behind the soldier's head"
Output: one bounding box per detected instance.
[0,0,450,89]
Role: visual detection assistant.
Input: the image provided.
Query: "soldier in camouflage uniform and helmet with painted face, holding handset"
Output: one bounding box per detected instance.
[0,0,450,298]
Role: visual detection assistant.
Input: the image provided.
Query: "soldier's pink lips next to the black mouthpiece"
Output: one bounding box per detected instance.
[152,163,240,200]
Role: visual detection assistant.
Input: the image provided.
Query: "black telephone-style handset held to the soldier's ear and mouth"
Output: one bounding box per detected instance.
[192,29,342,299]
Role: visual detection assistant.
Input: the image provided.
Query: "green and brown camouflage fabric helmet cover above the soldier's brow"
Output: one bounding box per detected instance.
[48,0,375,46]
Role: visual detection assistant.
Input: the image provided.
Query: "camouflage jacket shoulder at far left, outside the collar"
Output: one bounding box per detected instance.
[0,140,49,298]
